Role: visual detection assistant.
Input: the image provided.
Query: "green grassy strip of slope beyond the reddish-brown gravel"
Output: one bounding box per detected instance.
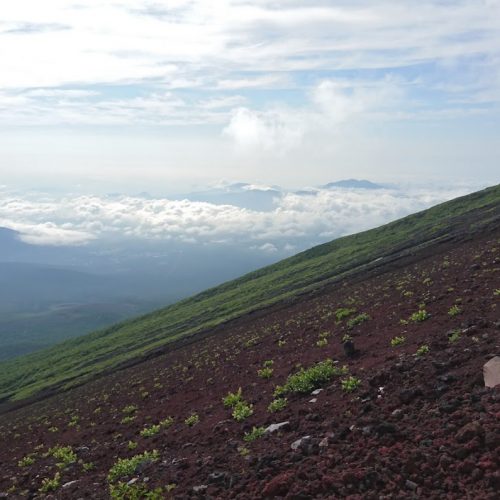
[0,185,500,400]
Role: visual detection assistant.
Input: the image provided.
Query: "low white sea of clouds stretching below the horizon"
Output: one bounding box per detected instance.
[0,184,474,253]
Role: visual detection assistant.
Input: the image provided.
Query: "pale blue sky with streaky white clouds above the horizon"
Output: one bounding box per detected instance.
[0,0,500,195]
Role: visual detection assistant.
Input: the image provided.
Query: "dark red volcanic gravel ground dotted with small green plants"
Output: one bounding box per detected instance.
[0,232,500,500]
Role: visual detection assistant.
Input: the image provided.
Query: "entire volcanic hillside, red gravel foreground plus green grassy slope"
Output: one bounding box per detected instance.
[0,186,500,500]
